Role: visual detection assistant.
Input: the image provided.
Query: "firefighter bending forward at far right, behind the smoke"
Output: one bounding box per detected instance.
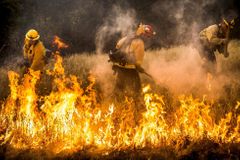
[199,19,230,74]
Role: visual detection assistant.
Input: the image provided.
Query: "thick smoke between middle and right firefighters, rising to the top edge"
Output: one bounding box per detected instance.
[122,0,234,98]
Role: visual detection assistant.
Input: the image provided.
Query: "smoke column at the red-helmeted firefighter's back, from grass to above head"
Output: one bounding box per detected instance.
[92,5,137,97]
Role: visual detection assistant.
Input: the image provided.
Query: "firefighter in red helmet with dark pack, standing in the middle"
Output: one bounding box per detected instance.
[109,24,155,97]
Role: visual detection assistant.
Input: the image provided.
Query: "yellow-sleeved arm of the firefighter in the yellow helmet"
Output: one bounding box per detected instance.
[31,42,46,70]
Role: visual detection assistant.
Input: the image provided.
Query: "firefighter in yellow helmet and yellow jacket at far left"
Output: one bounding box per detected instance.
[23,29,46,71]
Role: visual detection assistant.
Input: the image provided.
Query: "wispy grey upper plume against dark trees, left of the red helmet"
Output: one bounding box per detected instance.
[95,5,136,53]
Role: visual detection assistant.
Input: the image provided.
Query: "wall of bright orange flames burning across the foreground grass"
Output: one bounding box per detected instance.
[0,54,240,158]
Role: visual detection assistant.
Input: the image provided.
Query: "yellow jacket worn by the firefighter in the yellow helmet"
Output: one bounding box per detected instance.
[23,40,46,71]
